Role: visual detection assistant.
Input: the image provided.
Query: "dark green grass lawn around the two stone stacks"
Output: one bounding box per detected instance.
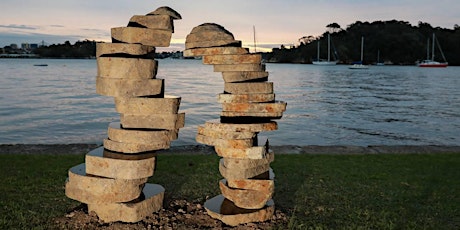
[0,153,460,229]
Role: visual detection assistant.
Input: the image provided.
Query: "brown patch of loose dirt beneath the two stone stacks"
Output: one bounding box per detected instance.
[54,200,288,230]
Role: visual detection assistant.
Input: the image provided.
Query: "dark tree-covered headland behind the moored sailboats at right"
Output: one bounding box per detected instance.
[264,20,460,65]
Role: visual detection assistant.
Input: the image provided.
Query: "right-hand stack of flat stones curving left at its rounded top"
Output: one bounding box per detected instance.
[184,23,286,226]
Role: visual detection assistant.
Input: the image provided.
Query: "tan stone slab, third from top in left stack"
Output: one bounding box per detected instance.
[111,27,172,47]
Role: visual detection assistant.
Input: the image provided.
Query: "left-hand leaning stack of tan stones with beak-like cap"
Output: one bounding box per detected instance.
[65,7,185,222]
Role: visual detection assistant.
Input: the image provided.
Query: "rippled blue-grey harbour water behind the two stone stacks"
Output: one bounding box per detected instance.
[0,59,460,146]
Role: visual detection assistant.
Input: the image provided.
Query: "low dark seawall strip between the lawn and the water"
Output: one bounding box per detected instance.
[0,144,460,155]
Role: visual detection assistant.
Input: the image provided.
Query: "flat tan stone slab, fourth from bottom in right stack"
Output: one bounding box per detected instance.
[219,159,270,180]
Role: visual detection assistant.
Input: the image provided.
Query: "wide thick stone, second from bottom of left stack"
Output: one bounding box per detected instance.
[65,163,147,204]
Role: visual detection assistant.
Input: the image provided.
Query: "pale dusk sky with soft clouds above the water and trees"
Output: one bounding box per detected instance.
[0,0,460,50]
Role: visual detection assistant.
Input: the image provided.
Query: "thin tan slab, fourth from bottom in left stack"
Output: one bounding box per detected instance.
[104,139,171,153]
